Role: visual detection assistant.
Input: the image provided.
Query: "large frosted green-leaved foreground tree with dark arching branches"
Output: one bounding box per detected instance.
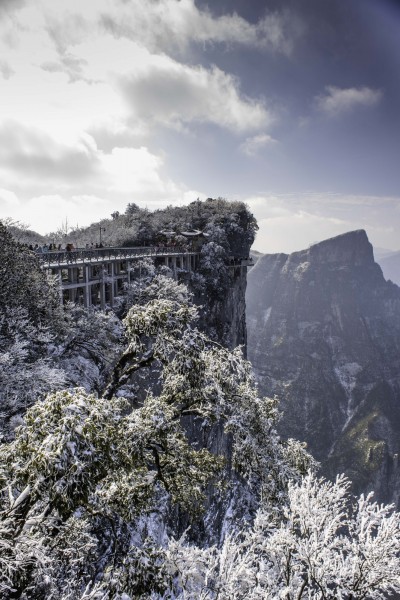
[0,290,310,600]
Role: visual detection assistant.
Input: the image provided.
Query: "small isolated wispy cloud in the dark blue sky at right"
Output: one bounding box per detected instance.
[316,86,383,117]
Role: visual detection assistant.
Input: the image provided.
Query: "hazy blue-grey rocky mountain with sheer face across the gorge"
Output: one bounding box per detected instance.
[247,230,400,504]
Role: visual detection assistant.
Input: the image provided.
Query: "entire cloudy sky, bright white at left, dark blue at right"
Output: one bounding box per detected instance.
[0,0,400,252]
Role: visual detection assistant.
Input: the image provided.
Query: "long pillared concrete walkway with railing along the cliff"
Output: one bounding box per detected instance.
[38,246,200,308]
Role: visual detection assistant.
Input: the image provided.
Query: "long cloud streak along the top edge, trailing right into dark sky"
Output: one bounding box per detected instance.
[100,0,296,53]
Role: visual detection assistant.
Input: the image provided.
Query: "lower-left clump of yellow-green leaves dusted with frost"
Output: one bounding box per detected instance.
[0,389,219,598]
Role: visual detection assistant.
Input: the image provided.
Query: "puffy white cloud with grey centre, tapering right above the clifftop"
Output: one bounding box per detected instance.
[119,57,272,132]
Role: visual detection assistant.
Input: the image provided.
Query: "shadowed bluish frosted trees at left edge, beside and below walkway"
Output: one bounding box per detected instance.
[0,222,123,439]
